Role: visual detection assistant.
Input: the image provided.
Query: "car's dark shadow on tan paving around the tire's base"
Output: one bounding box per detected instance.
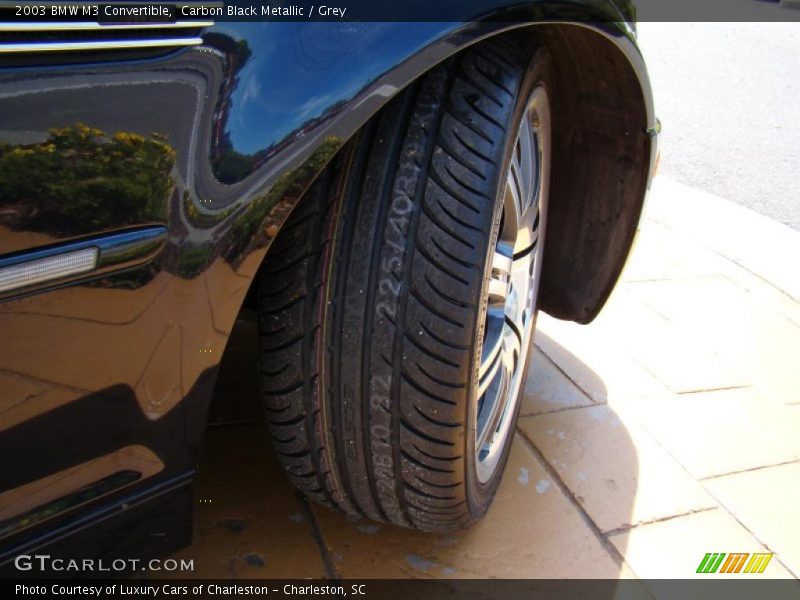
[164,320,638,591]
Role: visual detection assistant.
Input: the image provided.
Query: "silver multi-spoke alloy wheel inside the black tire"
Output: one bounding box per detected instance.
[473,87,550,483]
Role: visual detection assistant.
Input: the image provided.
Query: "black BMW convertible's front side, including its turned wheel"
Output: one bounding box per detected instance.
[0,0,657,569]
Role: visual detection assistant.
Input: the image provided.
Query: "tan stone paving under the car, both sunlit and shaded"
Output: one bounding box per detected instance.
[169,179,800,578]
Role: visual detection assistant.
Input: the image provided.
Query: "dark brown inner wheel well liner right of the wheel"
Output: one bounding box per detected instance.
[535,25,652,323]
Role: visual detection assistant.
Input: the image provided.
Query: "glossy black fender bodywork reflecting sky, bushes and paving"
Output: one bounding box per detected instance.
[0,2,654,563]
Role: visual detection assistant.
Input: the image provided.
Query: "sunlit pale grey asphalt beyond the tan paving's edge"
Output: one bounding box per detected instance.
[639,23,800,230]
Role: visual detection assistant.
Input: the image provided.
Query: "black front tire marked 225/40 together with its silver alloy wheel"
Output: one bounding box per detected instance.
[258,35,551,531]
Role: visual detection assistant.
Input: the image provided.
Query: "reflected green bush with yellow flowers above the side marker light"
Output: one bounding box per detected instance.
[0,123,175,237]
